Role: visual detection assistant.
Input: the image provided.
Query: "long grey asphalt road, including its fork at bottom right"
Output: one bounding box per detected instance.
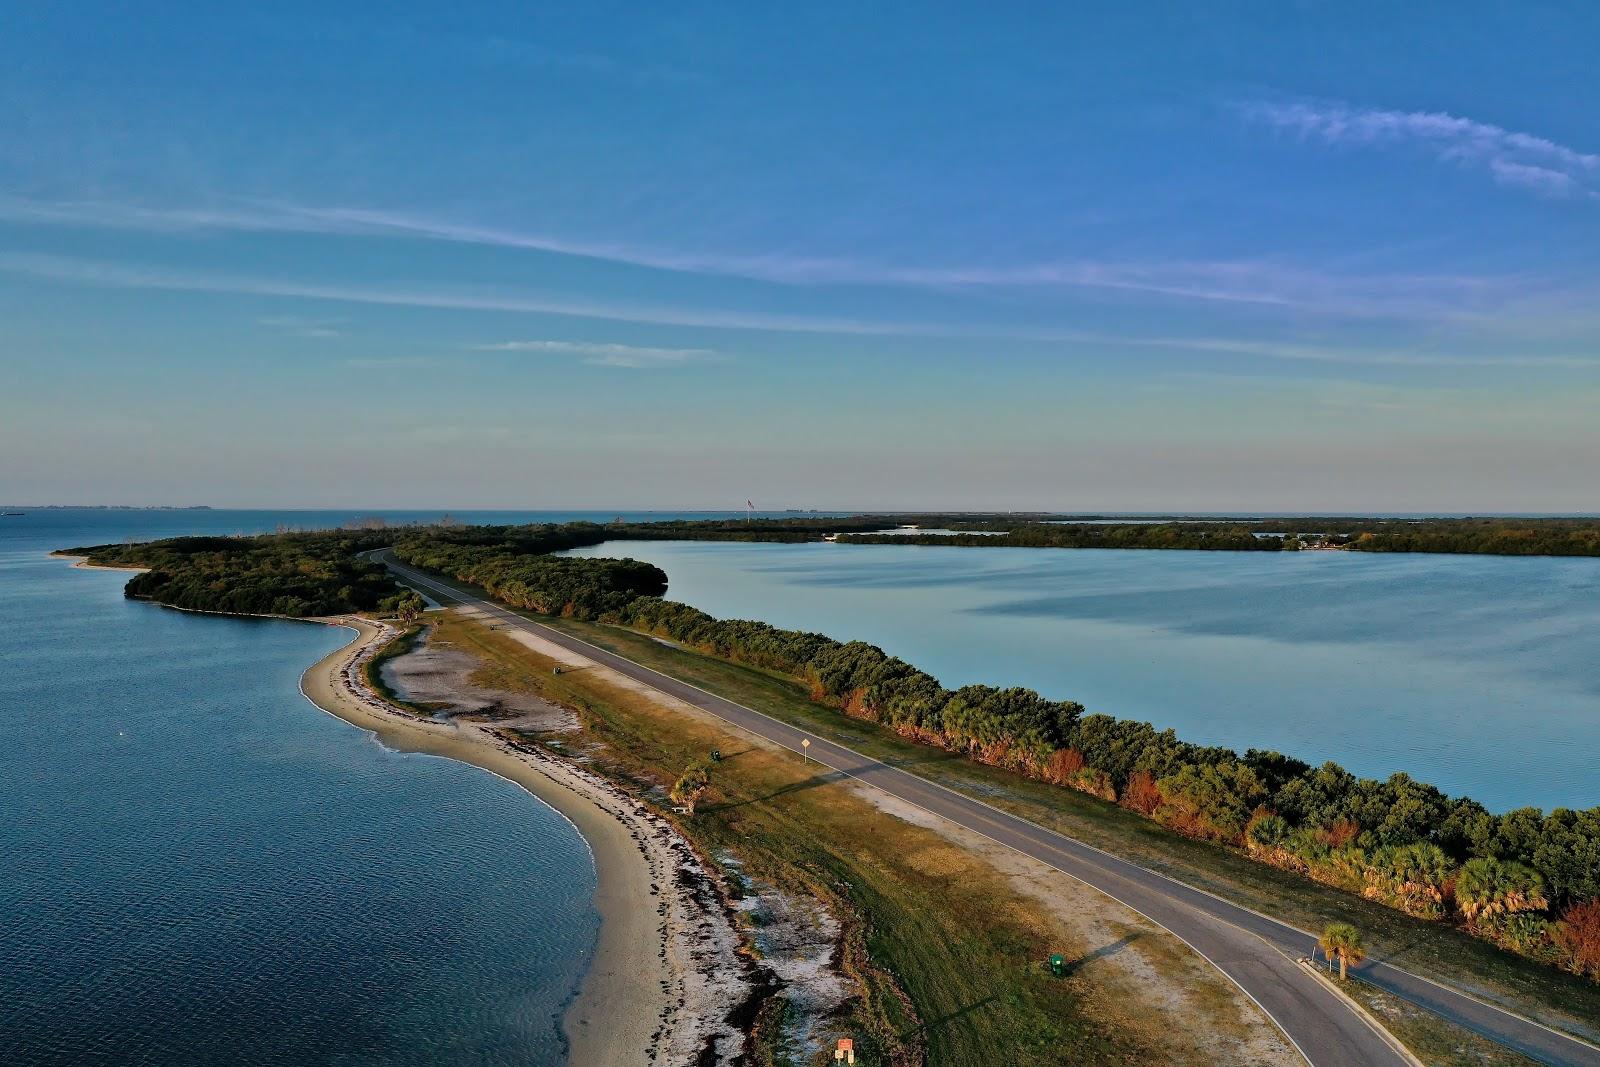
[374,552,1600,1067]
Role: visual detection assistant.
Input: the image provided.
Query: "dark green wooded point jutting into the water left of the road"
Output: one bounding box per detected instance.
[67,530,419,617]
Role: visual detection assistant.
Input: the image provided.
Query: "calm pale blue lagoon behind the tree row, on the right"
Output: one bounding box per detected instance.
[578,542,1600,811]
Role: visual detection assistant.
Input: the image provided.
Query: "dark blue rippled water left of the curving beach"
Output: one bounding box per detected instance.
[0,512,598,1065]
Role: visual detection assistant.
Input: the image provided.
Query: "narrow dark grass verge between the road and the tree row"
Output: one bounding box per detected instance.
[530,616,1600,1038]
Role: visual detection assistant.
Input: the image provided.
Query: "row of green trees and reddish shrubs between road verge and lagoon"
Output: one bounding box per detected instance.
[602,597,1600,977]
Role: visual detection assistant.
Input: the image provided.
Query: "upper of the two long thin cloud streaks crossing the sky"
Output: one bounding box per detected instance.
[0,194,1534,317]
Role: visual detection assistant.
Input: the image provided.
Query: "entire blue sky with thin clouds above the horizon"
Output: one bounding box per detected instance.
[0,0,1600,512]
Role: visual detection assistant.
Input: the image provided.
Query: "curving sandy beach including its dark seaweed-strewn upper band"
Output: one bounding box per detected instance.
[301,617,755,1067]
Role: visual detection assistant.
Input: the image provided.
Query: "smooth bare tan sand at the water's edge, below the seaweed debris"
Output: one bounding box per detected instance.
[301,617,678,1067]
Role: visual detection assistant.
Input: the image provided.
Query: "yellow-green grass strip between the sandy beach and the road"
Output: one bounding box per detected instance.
[430,616,1260,1067]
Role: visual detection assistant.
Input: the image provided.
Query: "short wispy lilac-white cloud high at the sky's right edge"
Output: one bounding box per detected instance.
[1238,101,1600,198]
